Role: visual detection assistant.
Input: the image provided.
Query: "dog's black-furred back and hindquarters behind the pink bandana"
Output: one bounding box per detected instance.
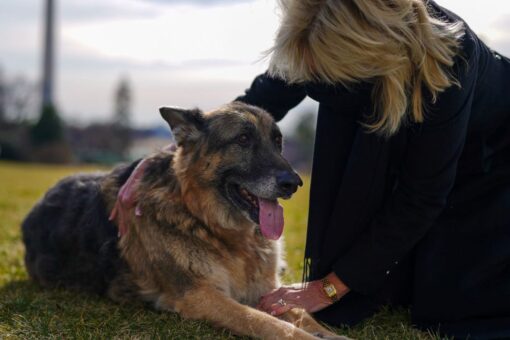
[22,163,136,294]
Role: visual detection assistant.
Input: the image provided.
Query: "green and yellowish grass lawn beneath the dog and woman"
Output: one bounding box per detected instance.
[0,162,435,339]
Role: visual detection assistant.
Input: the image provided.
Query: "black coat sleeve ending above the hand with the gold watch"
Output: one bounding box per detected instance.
[332,41,478,294]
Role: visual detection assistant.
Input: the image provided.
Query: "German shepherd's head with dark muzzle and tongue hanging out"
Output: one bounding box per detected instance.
[160,102,302,239]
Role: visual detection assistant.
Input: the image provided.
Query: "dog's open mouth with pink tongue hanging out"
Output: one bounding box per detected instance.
[227,183,284,240]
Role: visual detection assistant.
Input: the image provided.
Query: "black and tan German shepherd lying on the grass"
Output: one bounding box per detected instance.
[22,102,342,339]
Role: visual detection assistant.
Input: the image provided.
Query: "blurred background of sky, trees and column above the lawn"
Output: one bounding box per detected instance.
[0,0,510,171]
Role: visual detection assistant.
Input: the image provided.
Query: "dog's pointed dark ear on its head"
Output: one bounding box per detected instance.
[159,107,205,146]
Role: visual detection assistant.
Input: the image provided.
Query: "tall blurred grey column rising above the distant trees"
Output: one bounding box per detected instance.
[42,0,55,108]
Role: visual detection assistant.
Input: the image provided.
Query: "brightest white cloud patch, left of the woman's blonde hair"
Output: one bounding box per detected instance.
[62,1,278,65]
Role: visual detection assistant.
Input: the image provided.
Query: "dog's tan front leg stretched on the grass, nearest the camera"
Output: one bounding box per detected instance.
[163,287,317,340]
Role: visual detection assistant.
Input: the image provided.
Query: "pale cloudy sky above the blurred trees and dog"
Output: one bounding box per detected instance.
[0,0,510,128]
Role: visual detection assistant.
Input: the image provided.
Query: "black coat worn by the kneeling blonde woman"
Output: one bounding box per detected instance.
[238,1,510,337]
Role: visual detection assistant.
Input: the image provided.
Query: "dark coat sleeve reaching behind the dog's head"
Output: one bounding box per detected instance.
[235,72,306,121]
